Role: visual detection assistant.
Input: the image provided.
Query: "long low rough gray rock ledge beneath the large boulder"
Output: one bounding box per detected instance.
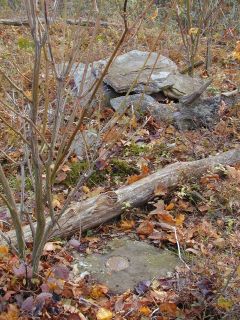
[110,94,229,130]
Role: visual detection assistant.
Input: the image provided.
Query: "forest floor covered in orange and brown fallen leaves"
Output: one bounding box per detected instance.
[0,13,240,320]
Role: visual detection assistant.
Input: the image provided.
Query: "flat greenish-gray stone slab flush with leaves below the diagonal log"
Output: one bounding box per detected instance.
[71,238,179,293]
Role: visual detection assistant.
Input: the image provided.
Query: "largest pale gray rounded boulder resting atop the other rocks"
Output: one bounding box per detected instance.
[104,50,178,94]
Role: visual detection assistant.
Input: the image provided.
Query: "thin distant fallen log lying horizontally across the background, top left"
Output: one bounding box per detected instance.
[0,18,119,27]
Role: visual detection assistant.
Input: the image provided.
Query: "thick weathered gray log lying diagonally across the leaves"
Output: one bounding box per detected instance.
[0,148,240,243]
